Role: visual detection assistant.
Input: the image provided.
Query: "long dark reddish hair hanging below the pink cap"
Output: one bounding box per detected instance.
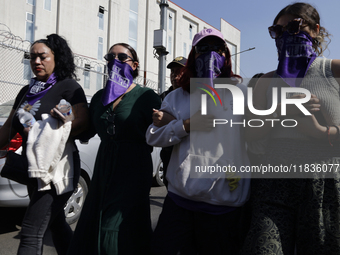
[178,41,242,93]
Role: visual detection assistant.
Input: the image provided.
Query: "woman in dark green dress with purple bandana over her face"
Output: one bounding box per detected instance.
[69,43,161,255]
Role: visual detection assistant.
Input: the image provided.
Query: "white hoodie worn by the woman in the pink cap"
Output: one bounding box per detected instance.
[146,84,250,207]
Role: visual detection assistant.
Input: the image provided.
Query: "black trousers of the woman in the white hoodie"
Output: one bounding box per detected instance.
[151,196,244,255]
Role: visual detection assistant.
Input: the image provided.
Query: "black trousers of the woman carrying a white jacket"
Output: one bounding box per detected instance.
[18,151,80,255]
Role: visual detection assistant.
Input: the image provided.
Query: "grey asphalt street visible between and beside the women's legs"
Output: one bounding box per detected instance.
[0,187,166,255]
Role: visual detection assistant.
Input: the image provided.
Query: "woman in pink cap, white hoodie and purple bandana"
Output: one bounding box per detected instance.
[146,28,250,255]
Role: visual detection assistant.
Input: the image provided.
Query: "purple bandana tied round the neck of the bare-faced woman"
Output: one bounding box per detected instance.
[26,73,58,105]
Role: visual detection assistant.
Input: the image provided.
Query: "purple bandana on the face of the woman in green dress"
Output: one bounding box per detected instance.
[102,59,133,106]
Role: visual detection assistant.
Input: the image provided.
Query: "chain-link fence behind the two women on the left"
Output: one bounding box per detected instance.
[0,23,158,104]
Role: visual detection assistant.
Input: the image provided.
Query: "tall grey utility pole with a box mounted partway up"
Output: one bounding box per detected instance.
[154,0,169,93]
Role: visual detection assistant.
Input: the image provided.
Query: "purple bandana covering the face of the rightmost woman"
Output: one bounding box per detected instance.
[275,31,316,87]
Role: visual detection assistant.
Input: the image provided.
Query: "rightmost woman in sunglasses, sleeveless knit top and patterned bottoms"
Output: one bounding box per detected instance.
[242,2,340,255]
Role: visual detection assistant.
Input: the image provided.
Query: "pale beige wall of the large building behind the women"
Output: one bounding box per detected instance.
[0,0,241,95]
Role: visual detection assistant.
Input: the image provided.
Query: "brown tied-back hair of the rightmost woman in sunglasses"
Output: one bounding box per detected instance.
[273,2,331,56]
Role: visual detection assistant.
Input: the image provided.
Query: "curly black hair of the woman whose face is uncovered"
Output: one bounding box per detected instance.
[31,34,77,81]
